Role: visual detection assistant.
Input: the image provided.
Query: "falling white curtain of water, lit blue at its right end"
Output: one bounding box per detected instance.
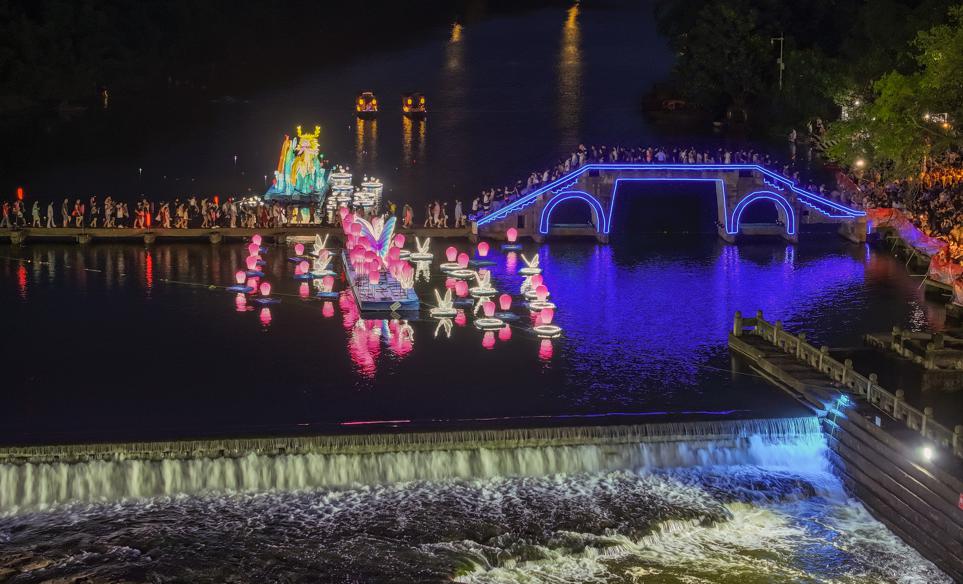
[0,418,824,512]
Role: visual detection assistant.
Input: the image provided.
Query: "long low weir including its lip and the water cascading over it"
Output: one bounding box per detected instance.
[0,416,825,511]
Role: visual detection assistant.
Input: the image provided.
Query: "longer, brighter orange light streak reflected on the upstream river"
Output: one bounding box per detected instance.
[557,2,582,151]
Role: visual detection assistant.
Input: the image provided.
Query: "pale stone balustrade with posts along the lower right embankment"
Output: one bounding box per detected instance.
[732,311,963,458]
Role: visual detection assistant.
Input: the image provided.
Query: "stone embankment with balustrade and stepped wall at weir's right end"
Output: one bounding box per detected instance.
[729,312,963,581]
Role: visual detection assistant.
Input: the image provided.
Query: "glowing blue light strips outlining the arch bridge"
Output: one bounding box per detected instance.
[476,164,865,236]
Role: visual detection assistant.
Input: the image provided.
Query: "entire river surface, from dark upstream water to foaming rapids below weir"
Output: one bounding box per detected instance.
[0,4,948,584]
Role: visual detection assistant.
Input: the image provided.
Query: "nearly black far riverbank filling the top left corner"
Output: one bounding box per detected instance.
[0,0,548,112]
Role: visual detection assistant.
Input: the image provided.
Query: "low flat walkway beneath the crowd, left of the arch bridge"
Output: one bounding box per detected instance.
[0,225,473,245]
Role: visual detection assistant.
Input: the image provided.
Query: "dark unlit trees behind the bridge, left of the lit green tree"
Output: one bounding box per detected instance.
[656,0,959,127]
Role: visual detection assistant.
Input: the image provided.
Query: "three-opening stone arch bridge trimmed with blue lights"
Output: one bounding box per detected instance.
[473,164,866,242]
